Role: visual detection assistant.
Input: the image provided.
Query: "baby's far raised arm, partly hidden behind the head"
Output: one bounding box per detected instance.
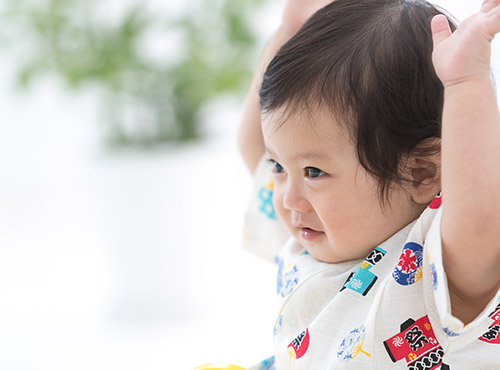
[238,0,332,173]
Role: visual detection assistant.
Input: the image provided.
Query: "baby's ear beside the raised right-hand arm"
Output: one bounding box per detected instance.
[407,138,441,204]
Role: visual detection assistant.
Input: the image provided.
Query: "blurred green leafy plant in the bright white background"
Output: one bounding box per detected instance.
[2,0,267,145]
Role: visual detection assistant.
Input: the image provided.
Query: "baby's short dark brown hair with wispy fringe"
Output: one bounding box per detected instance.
[260,0,456,201]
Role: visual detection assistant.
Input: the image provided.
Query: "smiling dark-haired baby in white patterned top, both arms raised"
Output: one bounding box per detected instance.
[240,0,500,370]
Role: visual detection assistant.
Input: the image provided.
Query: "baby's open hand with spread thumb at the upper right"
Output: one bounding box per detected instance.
[431,0,500,87]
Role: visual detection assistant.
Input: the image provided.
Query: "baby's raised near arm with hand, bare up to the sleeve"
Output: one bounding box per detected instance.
[432,0,500,323]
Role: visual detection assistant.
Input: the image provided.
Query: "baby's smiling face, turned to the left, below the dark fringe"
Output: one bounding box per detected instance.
[262,110,422,262]
